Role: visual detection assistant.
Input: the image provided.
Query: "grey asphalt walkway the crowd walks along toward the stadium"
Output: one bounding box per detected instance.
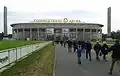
[55,45,120,76]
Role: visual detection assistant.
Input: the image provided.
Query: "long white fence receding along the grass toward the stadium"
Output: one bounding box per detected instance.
[0,42,51,68]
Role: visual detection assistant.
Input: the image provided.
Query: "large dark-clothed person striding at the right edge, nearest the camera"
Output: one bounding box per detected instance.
[109,40,120,75]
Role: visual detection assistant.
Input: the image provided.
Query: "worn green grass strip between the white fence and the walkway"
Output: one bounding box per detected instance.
[0,44,55,76]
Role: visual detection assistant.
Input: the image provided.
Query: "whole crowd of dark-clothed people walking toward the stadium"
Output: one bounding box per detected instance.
[56,40,120,75]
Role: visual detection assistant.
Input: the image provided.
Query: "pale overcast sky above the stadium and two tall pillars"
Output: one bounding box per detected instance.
[0,0,120,33]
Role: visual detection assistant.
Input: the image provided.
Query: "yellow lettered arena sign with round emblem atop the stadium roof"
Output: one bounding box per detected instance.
[32,18,81,23]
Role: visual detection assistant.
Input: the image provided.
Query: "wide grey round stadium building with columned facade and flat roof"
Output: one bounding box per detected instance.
[11,18,103,40]
